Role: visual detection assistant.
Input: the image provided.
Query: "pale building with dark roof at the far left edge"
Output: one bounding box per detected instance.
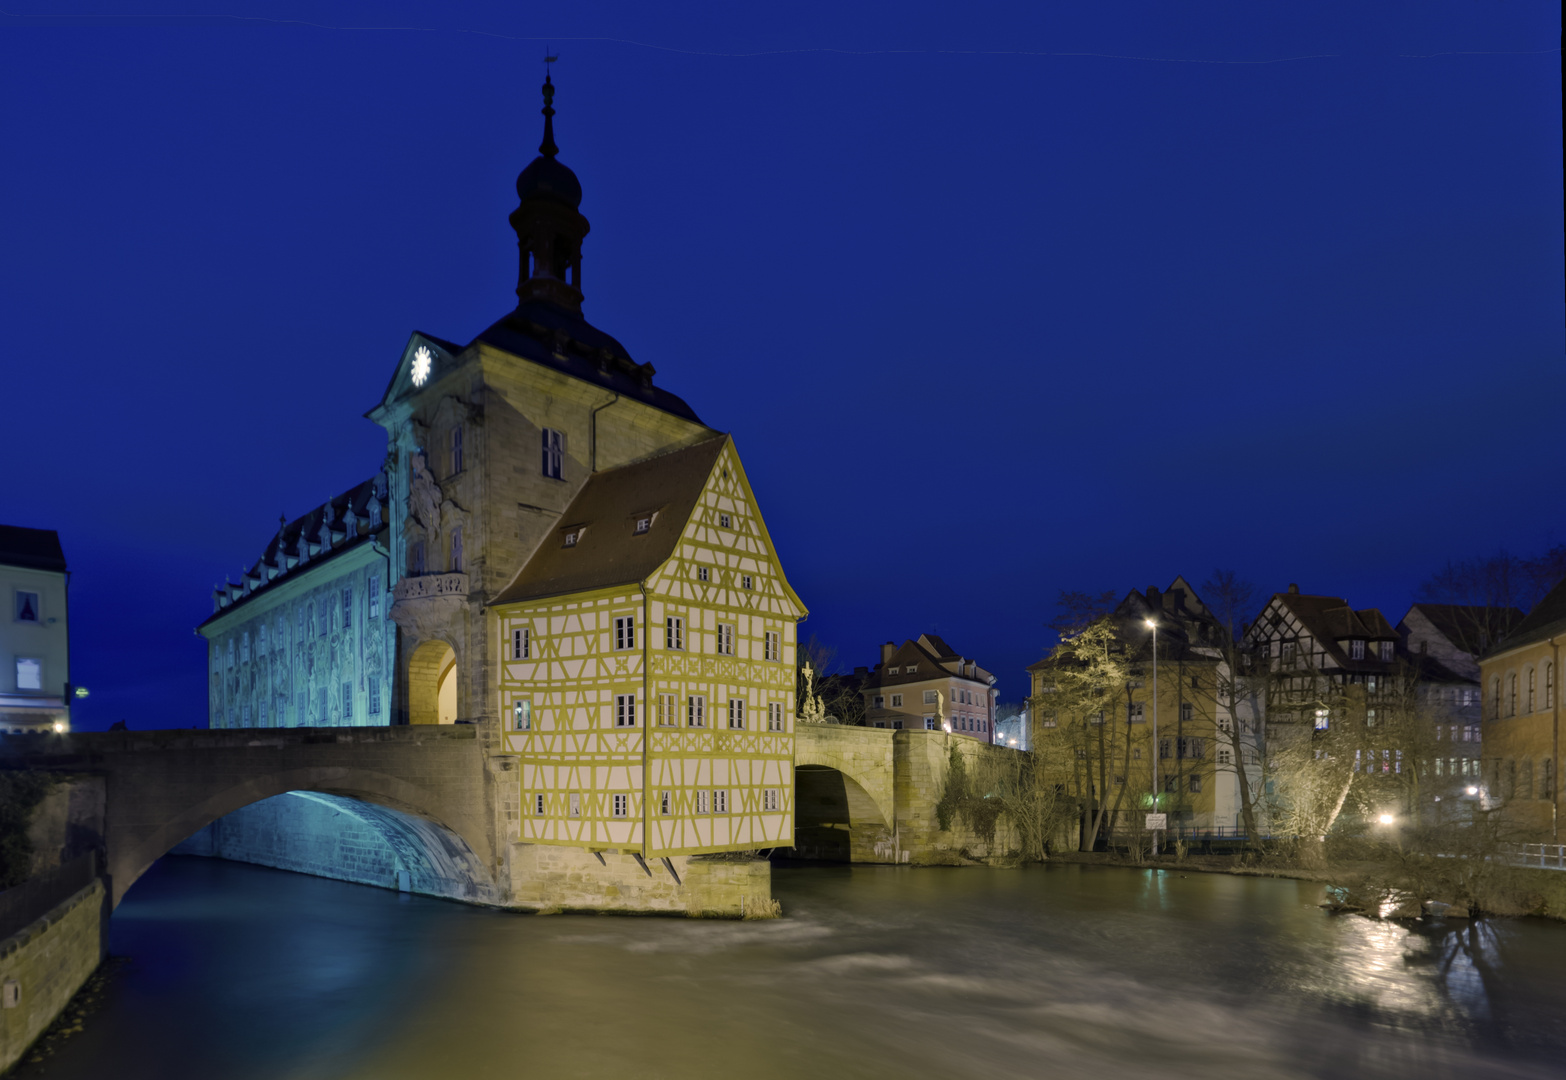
[0,524,74,733]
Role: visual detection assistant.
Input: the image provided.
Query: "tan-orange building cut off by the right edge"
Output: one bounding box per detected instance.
[1480,579,1566,842]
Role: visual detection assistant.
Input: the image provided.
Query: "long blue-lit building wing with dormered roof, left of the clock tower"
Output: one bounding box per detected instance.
[196,474,394,728]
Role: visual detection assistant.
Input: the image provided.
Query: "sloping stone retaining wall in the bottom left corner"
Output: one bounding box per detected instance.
[0,880,108,1072]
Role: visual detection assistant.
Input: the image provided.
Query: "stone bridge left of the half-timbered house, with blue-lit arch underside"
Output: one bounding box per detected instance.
[0,725,504,906]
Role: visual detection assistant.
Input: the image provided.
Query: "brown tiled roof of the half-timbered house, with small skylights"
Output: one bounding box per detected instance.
[490,435,728,604]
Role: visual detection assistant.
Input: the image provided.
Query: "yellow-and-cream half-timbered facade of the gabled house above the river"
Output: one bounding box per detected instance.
[490,432,805,858]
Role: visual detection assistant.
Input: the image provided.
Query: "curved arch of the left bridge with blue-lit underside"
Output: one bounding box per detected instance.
[108,765,498,906]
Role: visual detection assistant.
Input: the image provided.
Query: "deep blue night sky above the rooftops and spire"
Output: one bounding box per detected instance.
[0,0,1566,728]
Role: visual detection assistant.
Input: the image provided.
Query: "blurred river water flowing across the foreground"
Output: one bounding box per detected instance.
[16,856,1566,1080]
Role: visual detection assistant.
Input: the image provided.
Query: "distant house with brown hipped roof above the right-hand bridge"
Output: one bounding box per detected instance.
[860,634,996,742]
